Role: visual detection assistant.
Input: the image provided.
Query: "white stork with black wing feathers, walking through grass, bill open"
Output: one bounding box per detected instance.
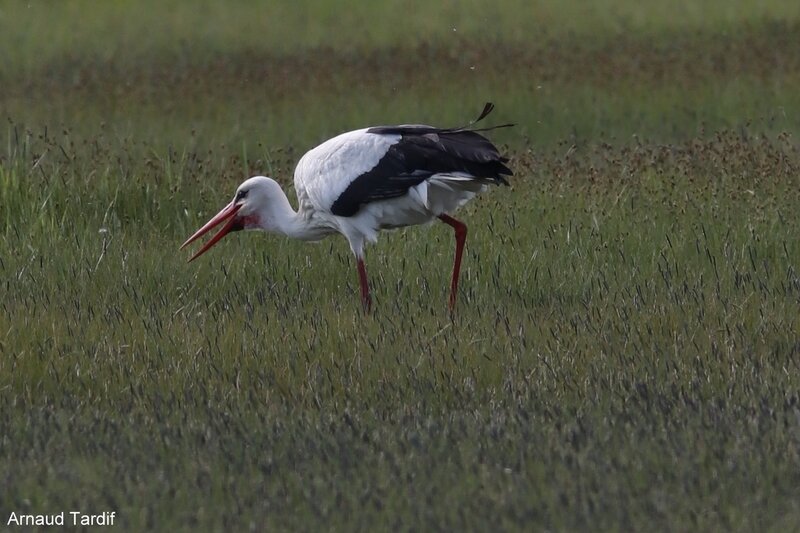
[181,103,512,311]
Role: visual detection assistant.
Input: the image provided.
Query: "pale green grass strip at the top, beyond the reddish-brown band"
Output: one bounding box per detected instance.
[0,0,800,72]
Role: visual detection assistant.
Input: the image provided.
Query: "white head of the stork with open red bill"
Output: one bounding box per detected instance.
[181,176,280,261]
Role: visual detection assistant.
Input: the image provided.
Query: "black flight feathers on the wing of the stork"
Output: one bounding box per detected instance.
[331,103,512,217]
